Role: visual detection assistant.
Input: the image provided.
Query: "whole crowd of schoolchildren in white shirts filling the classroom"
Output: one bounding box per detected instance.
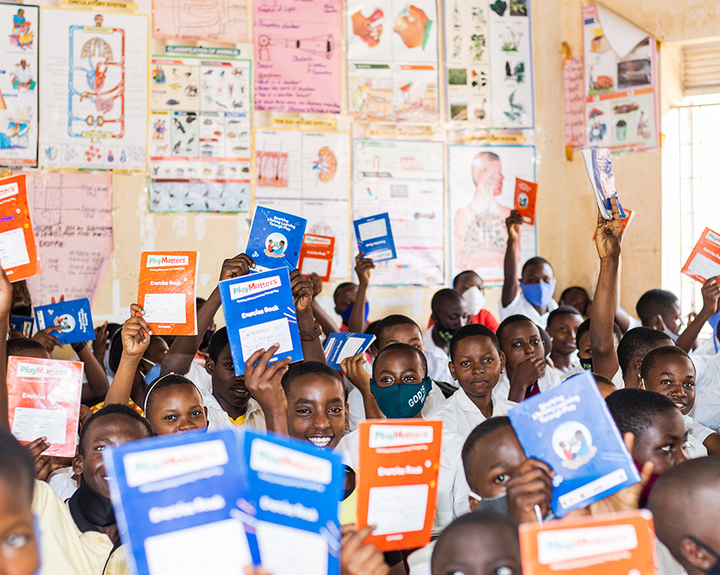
[0,195,720,575]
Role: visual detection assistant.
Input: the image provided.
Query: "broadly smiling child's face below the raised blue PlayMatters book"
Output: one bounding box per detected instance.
[287,373,348,449]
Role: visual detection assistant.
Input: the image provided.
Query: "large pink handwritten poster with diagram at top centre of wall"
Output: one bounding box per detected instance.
[253,0,342,114]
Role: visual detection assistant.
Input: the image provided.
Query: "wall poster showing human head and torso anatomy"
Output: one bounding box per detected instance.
[448,146,542,286]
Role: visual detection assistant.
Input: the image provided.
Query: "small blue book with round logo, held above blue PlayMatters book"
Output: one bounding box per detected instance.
[245,206,307,271]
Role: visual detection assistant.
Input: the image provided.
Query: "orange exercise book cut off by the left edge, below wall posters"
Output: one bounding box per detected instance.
[0,175,41,282]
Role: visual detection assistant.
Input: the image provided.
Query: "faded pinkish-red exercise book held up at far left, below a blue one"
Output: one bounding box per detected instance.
[7,356,83,457]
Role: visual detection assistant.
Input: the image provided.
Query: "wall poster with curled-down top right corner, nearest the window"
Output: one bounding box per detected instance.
[583,6,658,151]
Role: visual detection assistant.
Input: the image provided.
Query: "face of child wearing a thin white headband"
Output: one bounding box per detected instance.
[146,385,207,435]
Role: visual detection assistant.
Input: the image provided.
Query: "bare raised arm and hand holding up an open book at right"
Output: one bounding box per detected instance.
[590,199,622,379]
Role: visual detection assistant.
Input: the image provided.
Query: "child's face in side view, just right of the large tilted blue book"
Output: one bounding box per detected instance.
[632,410,688,475]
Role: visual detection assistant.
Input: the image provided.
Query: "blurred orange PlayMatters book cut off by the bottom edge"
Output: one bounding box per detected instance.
[520,509,657,575]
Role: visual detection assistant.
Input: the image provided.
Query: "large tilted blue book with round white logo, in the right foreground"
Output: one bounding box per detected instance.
[508,371,640,517]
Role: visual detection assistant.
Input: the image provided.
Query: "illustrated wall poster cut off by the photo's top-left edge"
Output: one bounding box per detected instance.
[0,4,40,168]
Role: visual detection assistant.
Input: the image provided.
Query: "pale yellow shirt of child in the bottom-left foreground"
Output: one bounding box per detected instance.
[33,481,129,575]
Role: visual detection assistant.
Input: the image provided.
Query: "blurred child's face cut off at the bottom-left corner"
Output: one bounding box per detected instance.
[0,479,40,575]
